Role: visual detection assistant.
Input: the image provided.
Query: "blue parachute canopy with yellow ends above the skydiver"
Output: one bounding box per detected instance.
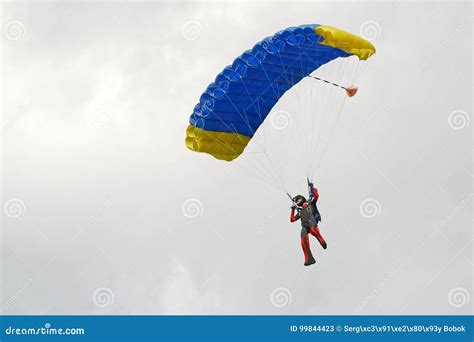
[186,25,375,161]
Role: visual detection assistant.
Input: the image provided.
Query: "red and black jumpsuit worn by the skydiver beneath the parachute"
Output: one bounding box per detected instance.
[290,187,327,266]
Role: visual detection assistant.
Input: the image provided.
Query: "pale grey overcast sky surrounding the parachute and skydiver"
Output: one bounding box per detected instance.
[1,1,473,314]
